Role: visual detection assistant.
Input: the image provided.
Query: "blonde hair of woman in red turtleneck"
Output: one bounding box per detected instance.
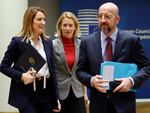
[55,11,80,38]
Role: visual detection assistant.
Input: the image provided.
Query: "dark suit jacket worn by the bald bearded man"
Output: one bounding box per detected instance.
[76,30,150,113]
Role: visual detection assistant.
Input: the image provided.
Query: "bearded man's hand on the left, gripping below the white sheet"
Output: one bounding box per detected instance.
[91,75,108,93]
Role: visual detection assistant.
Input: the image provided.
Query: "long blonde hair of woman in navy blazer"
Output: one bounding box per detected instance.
[19,7,46,38]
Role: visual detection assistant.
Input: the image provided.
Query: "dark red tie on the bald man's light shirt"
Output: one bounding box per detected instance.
[106,37,112,61]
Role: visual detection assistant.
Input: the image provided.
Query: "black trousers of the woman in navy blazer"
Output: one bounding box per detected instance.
[19,80,52,113]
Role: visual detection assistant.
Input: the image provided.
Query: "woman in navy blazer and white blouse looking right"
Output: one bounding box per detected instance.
[0,7,60,113]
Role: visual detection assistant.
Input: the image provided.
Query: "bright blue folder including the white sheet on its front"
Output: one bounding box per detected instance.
[100,61,138,92]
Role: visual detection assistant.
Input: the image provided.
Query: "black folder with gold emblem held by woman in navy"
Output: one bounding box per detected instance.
[15,44,46,72]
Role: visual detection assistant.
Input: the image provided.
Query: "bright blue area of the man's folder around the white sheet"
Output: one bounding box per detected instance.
[100,61,137,79]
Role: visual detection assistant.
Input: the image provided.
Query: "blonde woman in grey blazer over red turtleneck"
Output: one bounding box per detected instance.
[53,11,87,113]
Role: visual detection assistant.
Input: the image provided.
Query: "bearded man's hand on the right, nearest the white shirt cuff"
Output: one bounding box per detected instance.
[113,78,132,92]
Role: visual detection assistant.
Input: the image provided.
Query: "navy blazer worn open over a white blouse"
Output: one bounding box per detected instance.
[0,37,58,109]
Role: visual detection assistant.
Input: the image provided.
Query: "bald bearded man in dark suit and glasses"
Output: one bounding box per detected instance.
[76,2,150,113]
